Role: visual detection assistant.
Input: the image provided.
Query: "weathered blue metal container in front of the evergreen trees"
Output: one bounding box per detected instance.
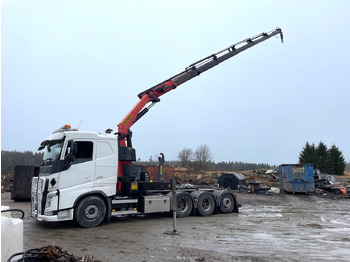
[279,164,315,194]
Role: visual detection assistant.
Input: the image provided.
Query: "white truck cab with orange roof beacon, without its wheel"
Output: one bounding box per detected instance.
[32,125,118,224]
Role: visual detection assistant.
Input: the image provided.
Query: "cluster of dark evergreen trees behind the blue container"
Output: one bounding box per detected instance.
[299,142,350,175]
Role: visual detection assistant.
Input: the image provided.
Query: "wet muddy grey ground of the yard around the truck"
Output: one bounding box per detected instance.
[2,193,350,262]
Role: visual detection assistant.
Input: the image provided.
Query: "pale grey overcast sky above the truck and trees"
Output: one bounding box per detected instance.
[1,0,350,165]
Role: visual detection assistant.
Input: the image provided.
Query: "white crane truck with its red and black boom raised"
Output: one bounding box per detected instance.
[31,28,283,227]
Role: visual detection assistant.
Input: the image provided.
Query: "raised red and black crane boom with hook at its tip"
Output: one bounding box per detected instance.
[118,28,283,147]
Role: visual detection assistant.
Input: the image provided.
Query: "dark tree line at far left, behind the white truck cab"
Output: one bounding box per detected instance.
[1,150,43,175]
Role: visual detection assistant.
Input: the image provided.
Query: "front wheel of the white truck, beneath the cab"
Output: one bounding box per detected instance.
[74,196,106,227]
